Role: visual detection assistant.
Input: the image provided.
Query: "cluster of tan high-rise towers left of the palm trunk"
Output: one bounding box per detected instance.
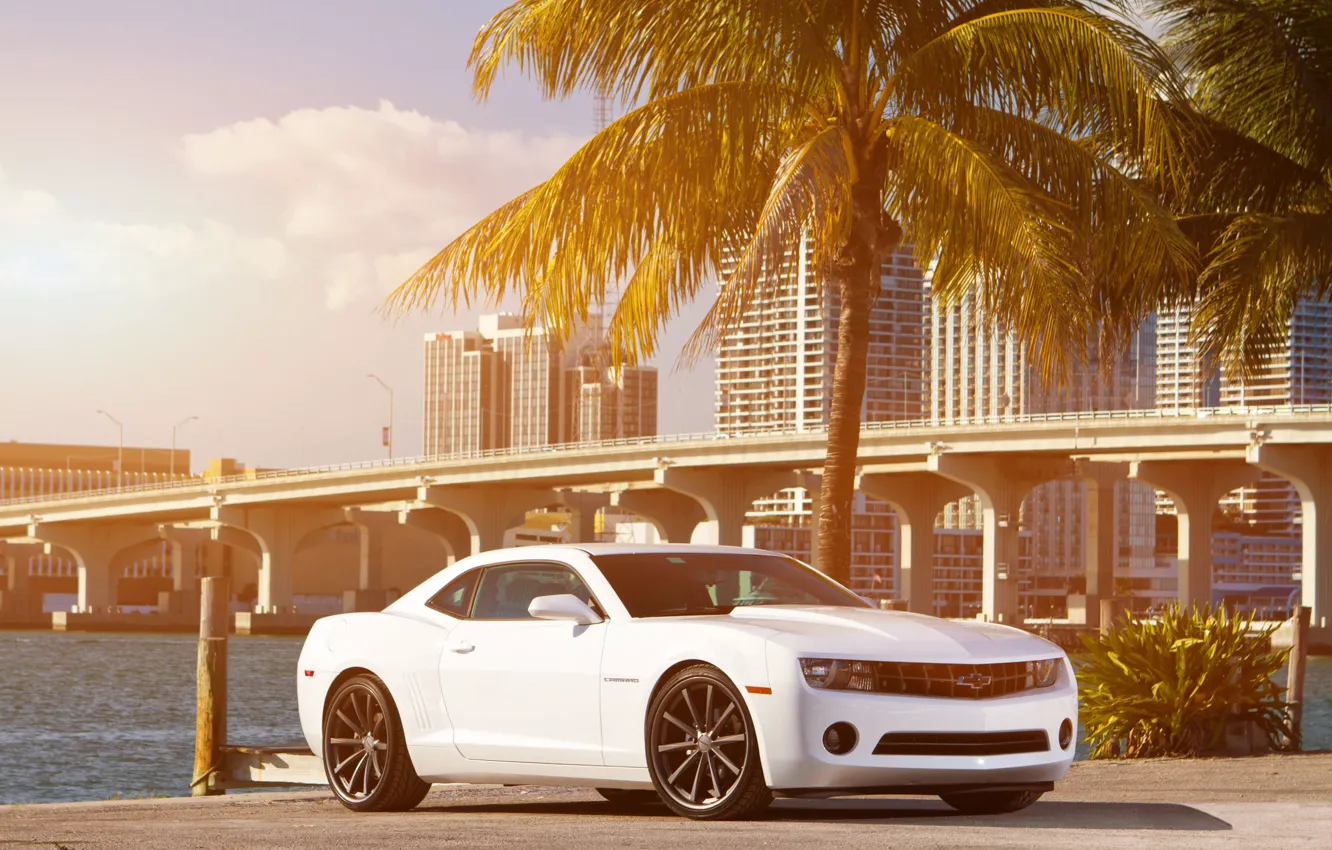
[424,314,657,456]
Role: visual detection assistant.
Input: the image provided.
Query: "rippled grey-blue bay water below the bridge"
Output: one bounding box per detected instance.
[0,632,1332,803]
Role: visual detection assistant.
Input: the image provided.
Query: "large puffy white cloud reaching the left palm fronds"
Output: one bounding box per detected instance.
[180,101,581,310]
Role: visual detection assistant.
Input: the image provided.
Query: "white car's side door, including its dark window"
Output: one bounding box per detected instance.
[440,562,606,765]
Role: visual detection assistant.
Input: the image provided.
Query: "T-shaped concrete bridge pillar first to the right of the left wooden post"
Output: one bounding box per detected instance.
[210,505,345,614]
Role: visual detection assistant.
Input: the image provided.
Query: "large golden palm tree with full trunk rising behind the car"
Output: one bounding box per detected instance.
[389,0,1196,581]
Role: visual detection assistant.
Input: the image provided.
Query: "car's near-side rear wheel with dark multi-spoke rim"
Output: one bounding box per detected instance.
[324,674,430,811]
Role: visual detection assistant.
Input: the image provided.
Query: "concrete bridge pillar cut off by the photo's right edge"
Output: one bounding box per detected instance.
[1247,444,1332,646]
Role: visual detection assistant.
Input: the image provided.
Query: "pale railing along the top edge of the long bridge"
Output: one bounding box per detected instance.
[0,405,1332,506]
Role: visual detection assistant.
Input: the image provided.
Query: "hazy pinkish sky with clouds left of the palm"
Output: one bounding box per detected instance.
[0,0,713,472]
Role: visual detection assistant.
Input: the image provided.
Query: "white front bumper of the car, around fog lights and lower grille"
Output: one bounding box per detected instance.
[747,658,1078,794]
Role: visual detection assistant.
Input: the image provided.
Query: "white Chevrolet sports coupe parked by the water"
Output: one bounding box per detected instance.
[297,545,1078,818]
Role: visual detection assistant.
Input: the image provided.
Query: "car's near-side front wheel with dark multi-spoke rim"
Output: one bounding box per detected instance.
[645,665,773,821]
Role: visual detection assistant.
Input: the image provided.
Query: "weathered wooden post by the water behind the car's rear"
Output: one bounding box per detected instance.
[189,578,230,797]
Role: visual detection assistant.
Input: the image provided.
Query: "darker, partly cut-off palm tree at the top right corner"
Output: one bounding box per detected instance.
[1147,0,1332,373]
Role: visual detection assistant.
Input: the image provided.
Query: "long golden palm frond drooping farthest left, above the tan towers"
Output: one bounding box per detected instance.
[390,83,793,357]
